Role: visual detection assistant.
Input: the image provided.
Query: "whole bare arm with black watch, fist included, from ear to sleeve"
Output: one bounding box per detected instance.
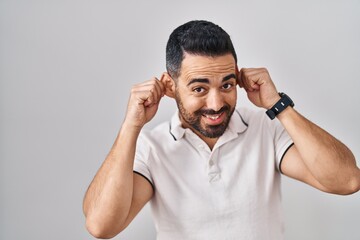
[239,69,360,194]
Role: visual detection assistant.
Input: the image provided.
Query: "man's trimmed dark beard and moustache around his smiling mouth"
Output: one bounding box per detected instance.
[176,93,235,138]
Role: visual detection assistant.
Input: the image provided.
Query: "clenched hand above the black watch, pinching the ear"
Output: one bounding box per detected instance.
[237,68,280,109]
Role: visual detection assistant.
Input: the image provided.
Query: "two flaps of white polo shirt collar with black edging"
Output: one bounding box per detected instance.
[169,109,248,141]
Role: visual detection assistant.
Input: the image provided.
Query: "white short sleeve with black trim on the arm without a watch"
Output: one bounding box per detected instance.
[133,133,154,187]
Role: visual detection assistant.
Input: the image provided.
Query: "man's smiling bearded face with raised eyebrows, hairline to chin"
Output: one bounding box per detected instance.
[175,53,237,138]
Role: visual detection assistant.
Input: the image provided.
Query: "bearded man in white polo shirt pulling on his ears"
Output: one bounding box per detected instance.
[84,21,360,240]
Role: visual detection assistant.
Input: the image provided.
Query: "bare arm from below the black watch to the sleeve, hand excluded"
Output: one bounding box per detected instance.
[278,108,360,194]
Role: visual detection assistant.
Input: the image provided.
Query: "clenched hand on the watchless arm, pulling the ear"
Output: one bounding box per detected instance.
[125,77,165,129]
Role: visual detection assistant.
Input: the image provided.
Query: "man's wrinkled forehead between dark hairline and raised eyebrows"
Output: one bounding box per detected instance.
[180,53,236,79]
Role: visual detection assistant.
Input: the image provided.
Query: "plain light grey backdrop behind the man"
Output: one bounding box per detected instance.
[0,0,360,240]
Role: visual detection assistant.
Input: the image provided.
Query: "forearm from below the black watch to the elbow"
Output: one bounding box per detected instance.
[278,107,360,193]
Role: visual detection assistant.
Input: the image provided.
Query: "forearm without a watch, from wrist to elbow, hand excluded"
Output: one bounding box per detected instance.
[83,125,140,235]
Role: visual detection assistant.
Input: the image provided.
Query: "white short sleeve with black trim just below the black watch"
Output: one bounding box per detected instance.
[269,118,294,171]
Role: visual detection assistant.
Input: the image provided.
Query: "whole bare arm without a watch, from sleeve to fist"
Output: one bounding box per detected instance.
[83,79,164,238]
